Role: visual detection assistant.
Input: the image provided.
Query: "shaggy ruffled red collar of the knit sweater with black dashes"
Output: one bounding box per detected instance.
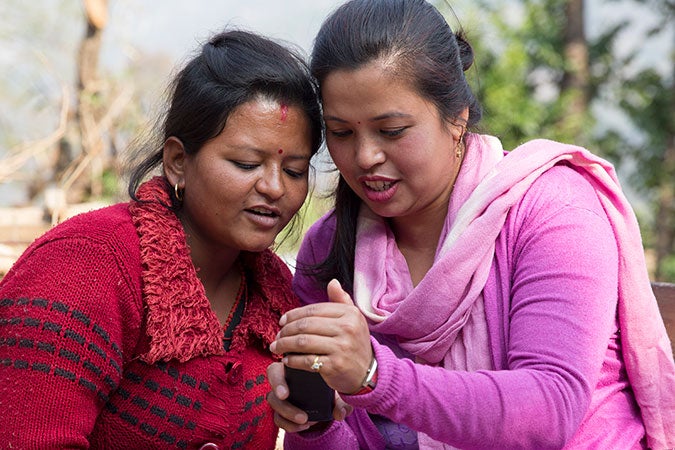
[129,177,297,364]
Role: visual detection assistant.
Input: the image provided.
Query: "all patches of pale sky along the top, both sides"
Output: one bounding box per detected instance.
[100,0,673,80]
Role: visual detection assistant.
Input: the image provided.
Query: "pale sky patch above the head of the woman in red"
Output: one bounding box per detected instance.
[104,0,342,69]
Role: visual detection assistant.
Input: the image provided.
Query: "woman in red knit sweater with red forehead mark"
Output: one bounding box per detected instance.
[0,31,322,449]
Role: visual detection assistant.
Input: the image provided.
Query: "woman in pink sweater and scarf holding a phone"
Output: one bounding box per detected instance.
[268,0,675,449]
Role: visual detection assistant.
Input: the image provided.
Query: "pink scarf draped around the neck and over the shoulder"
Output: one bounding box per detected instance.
[354,134,675,448]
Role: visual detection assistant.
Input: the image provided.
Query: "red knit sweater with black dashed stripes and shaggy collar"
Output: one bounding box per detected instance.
[0,179,296,449]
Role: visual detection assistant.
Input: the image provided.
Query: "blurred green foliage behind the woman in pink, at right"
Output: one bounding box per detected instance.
[436,0,675,281]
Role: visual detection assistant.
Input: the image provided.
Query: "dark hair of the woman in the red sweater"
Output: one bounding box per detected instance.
[128,30,323,208]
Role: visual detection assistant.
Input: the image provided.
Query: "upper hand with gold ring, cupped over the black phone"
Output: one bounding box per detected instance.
[270,280,373,394]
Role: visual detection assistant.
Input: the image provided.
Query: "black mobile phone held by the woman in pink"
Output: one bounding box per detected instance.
[284,366,335,422]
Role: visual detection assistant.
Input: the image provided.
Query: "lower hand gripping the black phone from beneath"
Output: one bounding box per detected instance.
[267,362,353,433]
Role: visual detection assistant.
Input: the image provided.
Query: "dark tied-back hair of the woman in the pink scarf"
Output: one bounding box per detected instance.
[301,0,482,288]
